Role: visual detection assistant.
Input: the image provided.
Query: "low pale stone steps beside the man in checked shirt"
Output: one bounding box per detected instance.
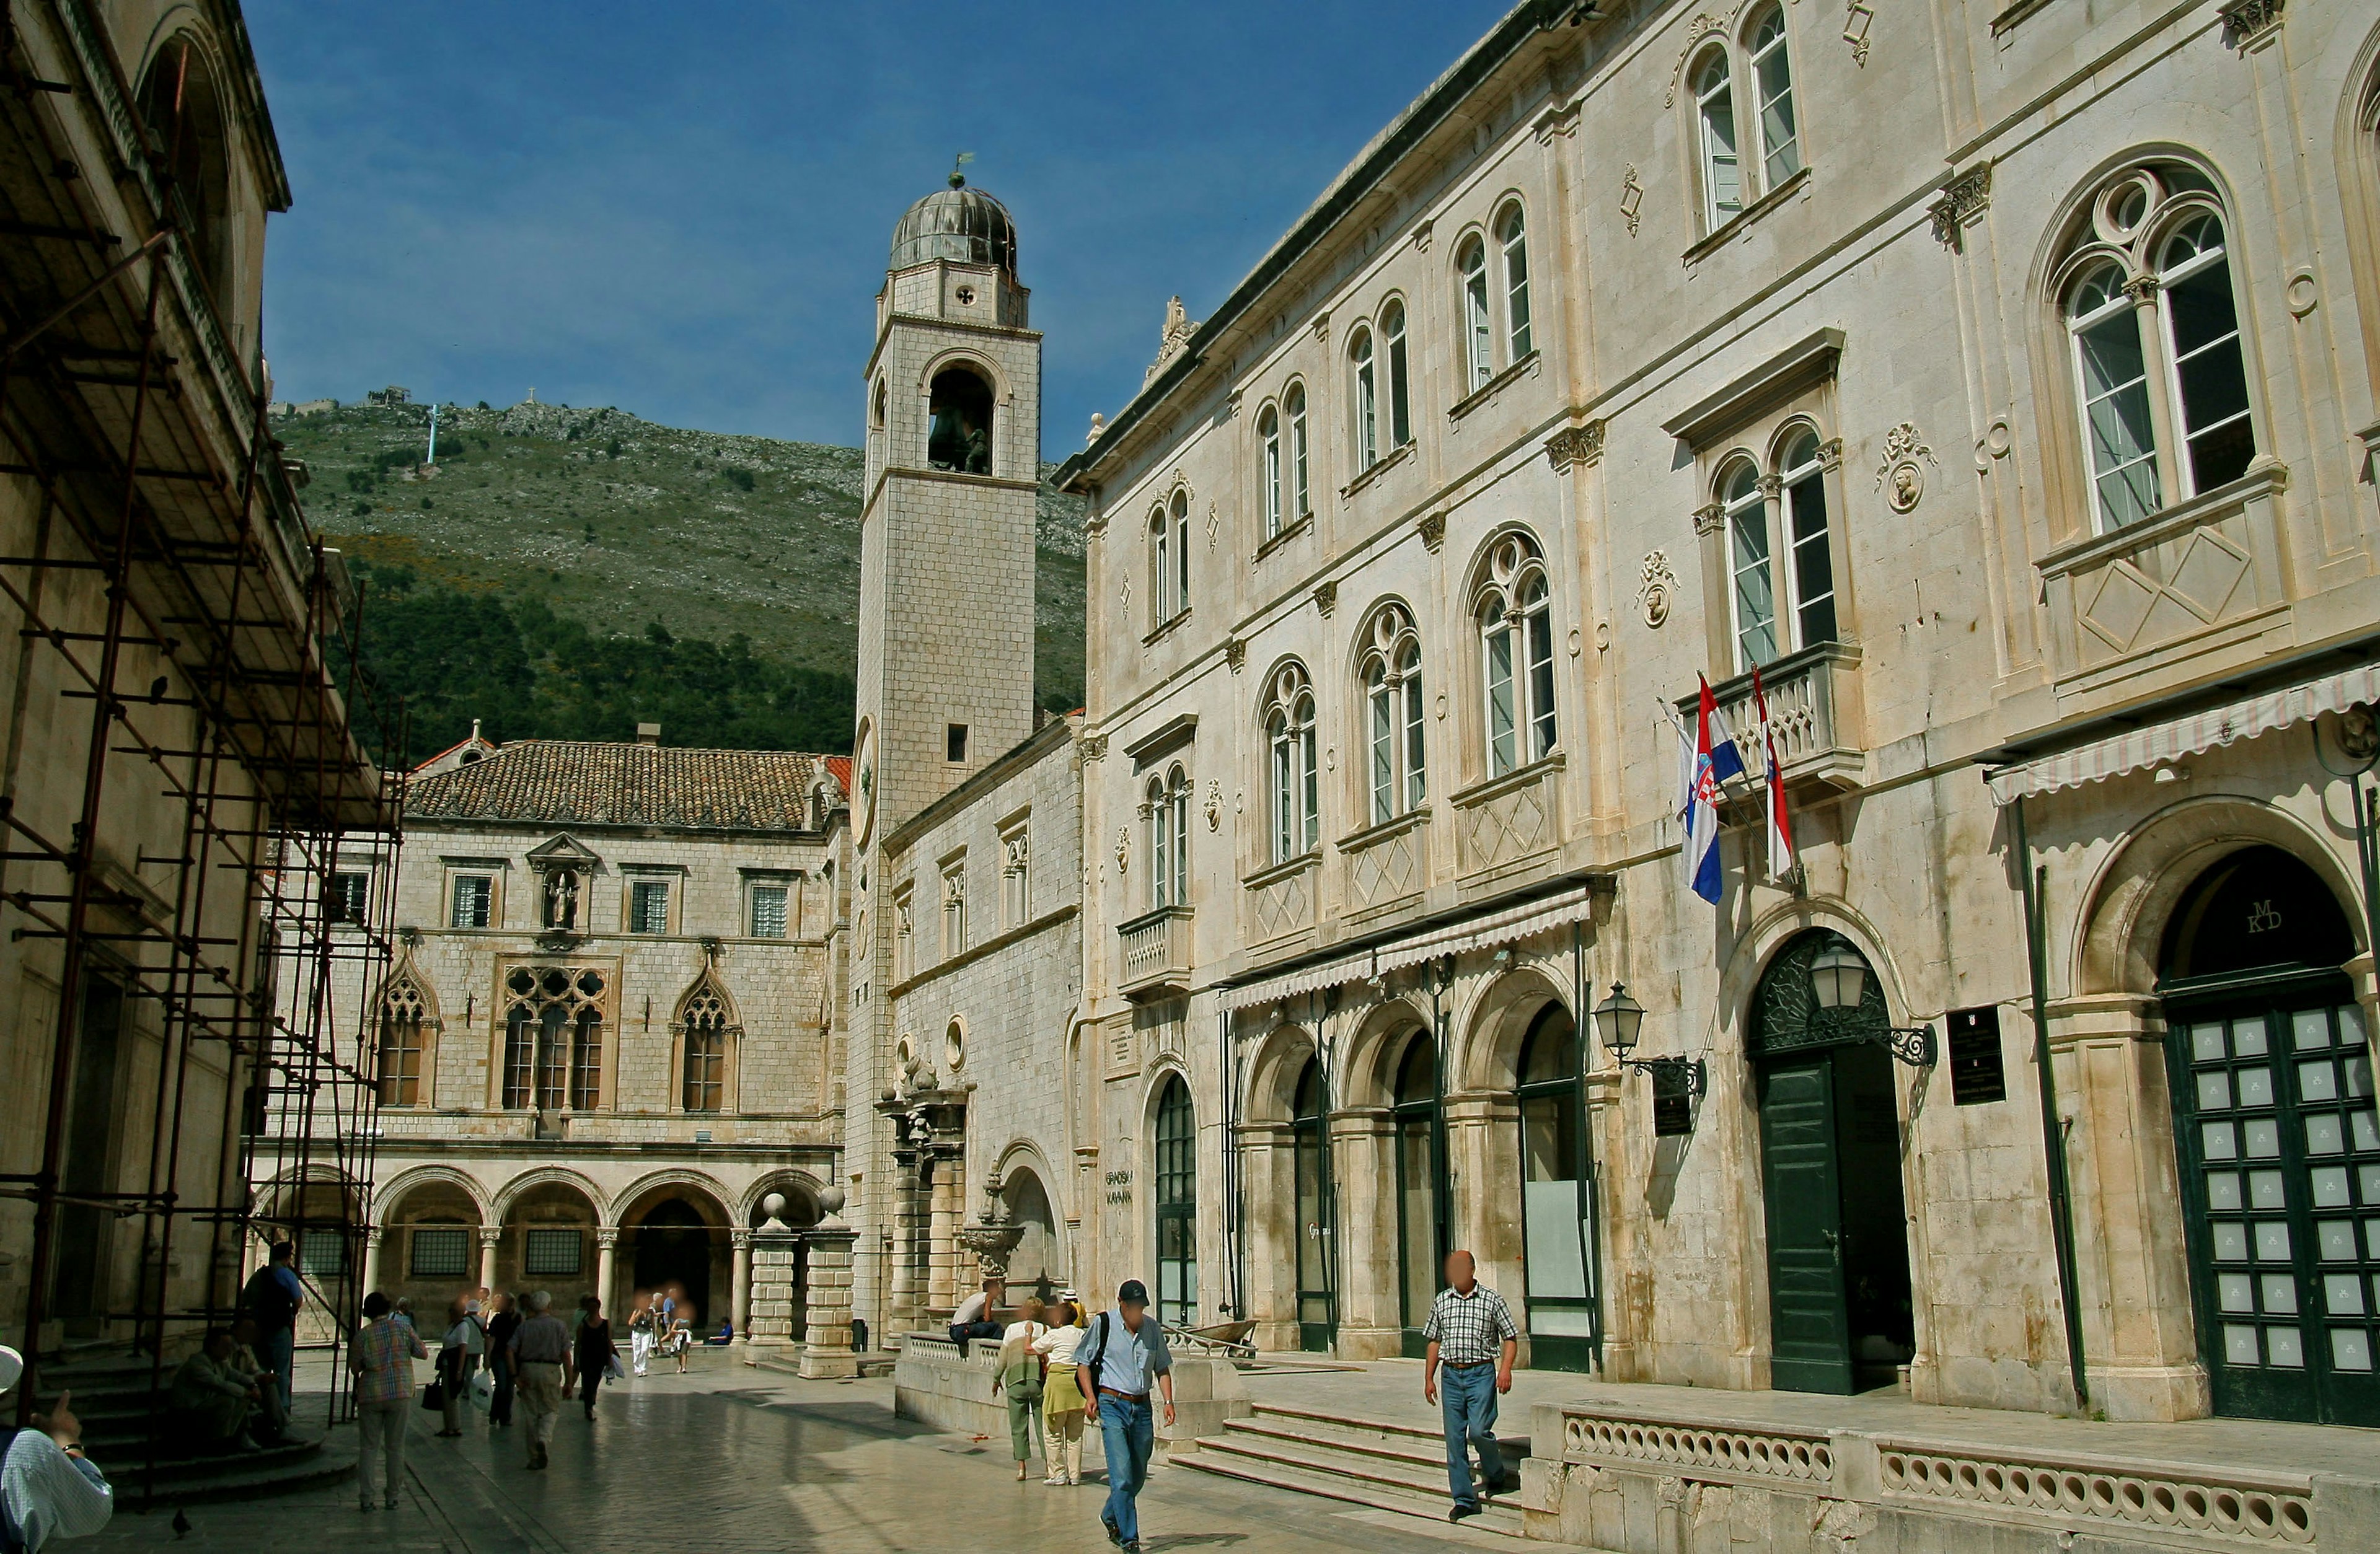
[1171,1407,1528,1537]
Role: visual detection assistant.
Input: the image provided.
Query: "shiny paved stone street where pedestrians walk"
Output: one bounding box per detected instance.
[76,1366,1514,1554]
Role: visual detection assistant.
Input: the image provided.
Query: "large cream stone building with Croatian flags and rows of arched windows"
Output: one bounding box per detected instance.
[1042,0,2380,1447]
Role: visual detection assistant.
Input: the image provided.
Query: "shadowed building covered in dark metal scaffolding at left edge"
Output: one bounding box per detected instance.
[0,0,405,1471]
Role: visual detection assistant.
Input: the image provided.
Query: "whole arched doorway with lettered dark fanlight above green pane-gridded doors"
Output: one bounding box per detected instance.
[2156,847,2380,1426]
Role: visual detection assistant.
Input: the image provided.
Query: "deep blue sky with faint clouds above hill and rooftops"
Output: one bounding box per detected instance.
[245,0,1504,459]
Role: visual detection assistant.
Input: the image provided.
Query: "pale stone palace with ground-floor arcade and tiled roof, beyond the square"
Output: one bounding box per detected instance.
[333,724,845,1333]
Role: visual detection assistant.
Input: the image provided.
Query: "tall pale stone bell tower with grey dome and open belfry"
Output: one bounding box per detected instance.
[852,172,1040,859]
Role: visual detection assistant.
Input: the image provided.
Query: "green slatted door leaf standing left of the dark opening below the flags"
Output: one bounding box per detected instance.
[1761,1052,1854,1395]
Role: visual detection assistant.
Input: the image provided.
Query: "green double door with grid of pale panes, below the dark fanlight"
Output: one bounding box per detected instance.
[2166,988,2380,1426]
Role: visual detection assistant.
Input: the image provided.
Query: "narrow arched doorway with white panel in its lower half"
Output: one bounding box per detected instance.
[1516,1004,1599,1371]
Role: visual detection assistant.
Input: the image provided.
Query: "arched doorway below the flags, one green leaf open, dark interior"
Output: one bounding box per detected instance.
[1747,928,1916,1392]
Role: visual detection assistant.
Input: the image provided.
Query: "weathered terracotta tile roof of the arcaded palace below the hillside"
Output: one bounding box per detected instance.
[405,740,835,830]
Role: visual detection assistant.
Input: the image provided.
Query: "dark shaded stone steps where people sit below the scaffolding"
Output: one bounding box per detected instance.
[40,1345,355,1509]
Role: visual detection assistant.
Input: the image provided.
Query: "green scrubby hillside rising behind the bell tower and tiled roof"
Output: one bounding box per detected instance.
[274,405,1083,757]
